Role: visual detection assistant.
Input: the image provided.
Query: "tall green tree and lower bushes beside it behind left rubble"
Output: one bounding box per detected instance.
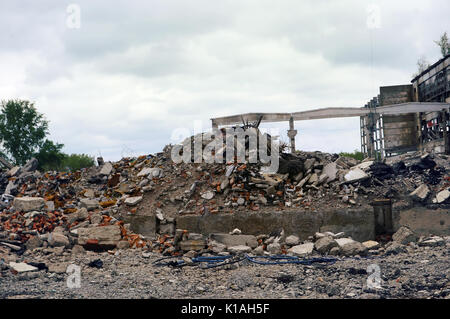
[0,99,94,171]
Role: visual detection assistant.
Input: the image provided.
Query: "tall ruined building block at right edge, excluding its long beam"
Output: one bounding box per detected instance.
[360,55,450,157]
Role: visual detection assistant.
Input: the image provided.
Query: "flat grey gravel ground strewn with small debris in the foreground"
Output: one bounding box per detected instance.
[0,242,450,299]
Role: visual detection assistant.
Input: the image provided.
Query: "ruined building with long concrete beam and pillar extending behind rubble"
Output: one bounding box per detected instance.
[211,55,450,160]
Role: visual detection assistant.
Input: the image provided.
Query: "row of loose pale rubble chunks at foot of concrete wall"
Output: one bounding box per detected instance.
[169,226,446,258]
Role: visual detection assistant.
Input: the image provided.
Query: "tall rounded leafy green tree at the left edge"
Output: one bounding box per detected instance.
[0,99,48,165]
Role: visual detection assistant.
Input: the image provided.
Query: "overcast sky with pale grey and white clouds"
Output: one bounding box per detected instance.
[0,0,450,160]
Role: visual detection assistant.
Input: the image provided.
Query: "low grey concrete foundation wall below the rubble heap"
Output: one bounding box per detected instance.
[125,204,450,241]
